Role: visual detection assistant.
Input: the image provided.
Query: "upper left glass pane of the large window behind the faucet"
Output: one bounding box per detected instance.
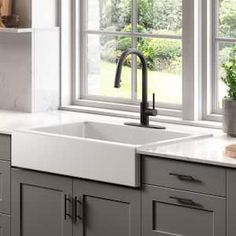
[87,0,131,31]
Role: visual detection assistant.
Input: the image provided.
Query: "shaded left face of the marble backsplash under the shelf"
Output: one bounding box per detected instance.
[0,34,31,112]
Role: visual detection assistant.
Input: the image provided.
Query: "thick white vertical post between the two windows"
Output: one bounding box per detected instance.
[183,0,201,120]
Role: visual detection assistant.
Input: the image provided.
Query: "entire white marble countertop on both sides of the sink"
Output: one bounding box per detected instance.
[0,110,236,168]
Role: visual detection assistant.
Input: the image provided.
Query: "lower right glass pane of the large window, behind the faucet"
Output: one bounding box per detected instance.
[138,38,182,105]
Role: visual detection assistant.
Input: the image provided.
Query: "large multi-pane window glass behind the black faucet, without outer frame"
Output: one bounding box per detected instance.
[77,0,183,109]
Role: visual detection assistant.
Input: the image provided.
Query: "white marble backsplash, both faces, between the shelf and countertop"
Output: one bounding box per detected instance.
[0,28,60,112]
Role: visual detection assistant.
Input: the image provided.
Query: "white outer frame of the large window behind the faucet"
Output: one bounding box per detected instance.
[61,0,205,120]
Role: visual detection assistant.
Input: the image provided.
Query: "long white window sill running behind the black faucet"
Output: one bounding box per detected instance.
[60,105,222,129]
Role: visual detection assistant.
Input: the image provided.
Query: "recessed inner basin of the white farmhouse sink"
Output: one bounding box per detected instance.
[35,122,192,146]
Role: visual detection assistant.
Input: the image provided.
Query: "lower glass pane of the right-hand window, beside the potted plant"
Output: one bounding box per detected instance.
[217,43,236,108]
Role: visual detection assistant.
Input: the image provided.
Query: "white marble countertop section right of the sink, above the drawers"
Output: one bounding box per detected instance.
[138,133,236,168]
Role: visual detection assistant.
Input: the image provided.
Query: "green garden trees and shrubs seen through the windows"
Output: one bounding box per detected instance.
[100,0,236,72]
